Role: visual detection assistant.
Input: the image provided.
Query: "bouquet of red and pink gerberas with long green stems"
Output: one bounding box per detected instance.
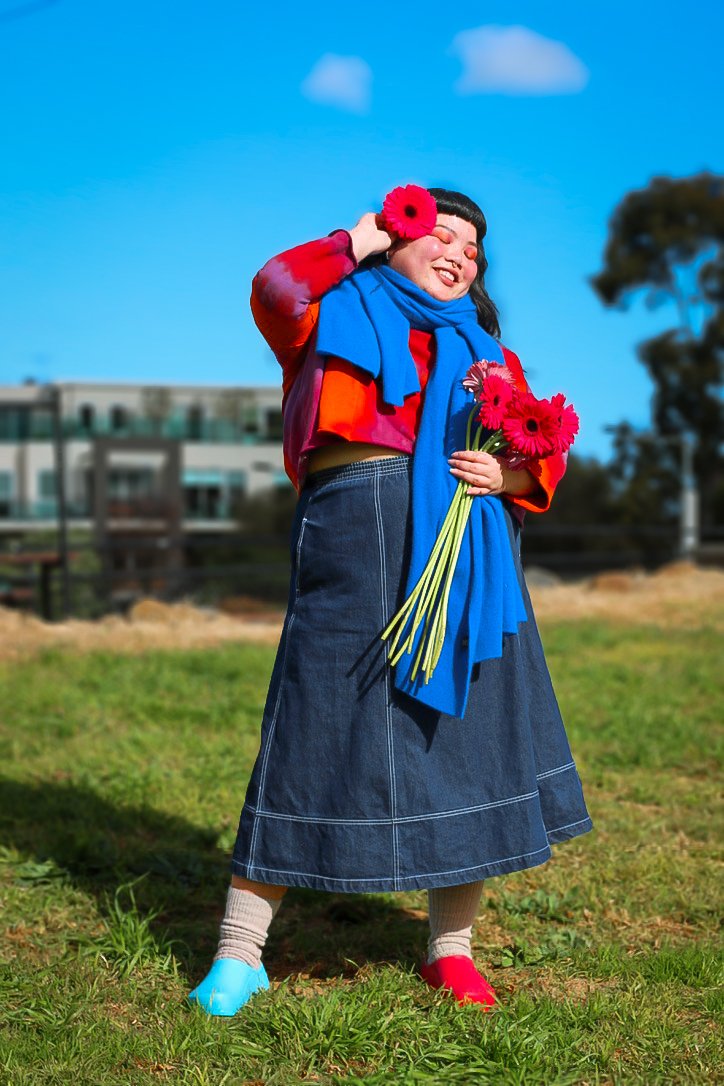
[382,359,579,683]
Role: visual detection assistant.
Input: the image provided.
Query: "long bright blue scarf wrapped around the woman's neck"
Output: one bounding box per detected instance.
[317,266,526,717]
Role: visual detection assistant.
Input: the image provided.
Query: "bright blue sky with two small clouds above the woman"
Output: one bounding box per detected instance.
[0,0,724,456]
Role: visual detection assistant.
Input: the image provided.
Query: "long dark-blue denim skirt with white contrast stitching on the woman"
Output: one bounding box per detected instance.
[231,456,592,893]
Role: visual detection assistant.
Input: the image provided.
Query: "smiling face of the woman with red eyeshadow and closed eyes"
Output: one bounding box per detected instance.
[389,215,478,302]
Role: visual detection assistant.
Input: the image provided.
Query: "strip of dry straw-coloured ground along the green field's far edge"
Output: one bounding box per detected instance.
[0,563,724,658]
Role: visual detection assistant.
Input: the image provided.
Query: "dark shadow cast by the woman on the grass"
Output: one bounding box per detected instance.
[0,778,427,980]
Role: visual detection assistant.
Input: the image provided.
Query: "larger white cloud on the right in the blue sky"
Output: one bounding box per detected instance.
[450,25,588,94]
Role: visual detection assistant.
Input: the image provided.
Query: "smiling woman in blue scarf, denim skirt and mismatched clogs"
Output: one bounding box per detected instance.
[190,189,592,1015]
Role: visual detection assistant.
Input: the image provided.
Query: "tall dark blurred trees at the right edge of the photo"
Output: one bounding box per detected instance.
[529,173,724,560]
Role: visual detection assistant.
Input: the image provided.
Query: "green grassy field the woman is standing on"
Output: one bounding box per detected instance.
[0,622,724,1086]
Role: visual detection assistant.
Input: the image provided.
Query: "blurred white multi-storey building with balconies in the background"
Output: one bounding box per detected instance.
[0,381,291,534]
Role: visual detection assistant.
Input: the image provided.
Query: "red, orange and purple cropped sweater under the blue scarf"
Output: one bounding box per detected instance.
[252,230,566,513]
